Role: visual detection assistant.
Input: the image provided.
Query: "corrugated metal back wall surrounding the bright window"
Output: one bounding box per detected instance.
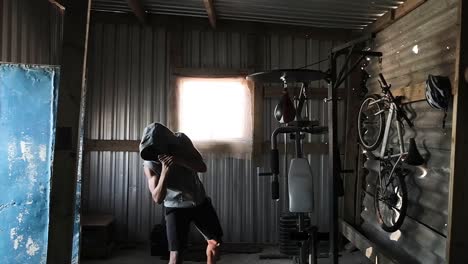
[83,16,348,243]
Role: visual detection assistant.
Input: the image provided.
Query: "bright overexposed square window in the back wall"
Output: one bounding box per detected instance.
[177,77,252,146]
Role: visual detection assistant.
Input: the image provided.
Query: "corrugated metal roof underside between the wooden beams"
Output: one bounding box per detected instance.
[93,0,405,30]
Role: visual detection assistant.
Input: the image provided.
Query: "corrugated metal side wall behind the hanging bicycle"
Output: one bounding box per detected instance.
[361,0,458,263]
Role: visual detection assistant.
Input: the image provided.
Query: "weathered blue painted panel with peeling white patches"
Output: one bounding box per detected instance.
[0,64,58,264]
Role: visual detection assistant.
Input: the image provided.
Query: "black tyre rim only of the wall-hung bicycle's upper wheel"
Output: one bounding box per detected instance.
[357,94,385,151]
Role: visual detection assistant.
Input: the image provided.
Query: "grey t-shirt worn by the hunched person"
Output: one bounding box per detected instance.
[143,133,206,208]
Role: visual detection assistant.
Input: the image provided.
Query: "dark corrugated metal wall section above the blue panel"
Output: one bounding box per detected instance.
[0,0,63,64]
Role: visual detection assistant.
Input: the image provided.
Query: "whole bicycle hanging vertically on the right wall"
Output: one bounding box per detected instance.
[357,74,424,232]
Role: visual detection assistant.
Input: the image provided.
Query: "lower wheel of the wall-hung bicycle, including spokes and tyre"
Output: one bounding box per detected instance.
[374,168,408,232]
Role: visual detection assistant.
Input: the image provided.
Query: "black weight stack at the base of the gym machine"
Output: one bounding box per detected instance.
[279,213,310,256]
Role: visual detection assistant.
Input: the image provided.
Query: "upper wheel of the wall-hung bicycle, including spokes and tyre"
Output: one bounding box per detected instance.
[358,94,385,151]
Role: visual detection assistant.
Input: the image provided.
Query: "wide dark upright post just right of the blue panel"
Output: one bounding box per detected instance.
[46,0,91,264]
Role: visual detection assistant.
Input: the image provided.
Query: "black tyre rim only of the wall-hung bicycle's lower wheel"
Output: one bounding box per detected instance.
[374,170,408,233]
